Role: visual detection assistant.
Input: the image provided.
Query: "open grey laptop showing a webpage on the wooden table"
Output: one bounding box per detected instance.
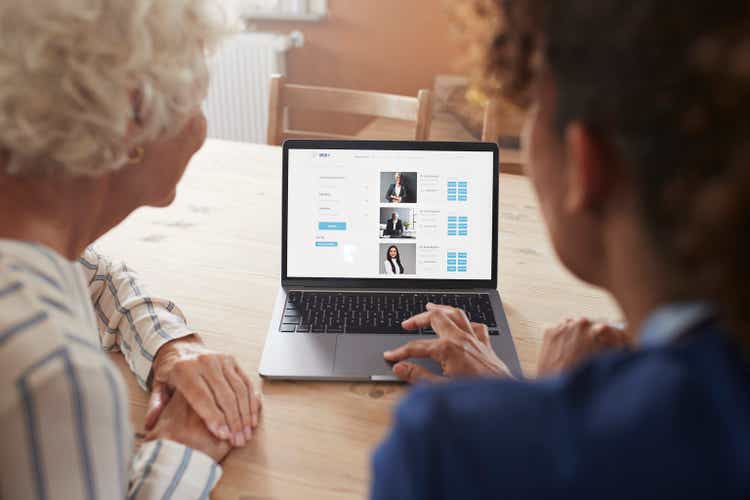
[259,140,521,381]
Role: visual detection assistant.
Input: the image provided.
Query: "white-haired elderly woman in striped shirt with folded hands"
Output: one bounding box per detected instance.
[0,0,260,499]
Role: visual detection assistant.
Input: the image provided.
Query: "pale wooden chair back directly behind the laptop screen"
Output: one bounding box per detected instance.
[268,75,432,146]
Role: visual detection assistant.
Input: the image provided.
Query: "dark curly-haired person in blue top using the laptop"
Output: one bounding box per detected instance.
[373,0,750,500]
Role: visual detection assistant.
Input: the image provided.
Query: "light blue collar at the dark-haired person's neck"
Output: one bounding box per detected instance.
[638,302,715,347]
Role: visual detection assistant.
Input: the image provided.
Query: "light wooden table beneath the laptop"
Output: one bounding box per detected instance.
[99,140,619,500]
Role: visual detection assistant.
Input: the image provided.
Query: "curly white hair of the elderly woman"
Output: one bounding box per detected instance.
[0,0,230,176]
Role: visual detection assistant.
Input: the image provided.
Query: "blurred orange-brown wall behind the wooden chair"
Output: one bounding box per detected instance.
[251,0,460,134]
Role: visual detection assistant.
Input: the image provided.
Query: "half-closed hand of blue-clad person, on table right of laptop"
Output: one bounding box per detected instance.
[537,318,632,376]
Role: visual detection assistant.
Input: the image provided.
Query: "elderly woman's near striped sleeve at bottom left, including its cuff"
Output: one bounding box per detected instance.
[5,347,222,500]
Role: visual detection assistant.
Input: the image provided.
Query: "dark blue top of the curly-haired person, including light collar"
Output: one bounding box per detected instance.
[372,304,750,500]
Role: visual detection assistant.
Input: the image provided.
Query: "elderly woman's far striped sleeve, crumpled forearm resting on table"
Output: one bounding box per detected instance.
[79,247,194,390]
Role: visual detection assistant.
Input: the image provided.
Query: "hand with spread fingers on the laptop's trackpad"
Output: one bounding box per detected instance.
[383,304,510,383]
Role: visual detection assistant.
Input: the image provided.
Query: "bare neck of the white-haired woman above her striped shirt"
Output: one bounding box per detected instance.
[0,173,121,261]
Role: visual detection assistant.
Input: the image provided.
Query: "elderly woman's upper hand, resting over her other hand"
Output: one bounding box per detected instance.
[145,335,261,446]
